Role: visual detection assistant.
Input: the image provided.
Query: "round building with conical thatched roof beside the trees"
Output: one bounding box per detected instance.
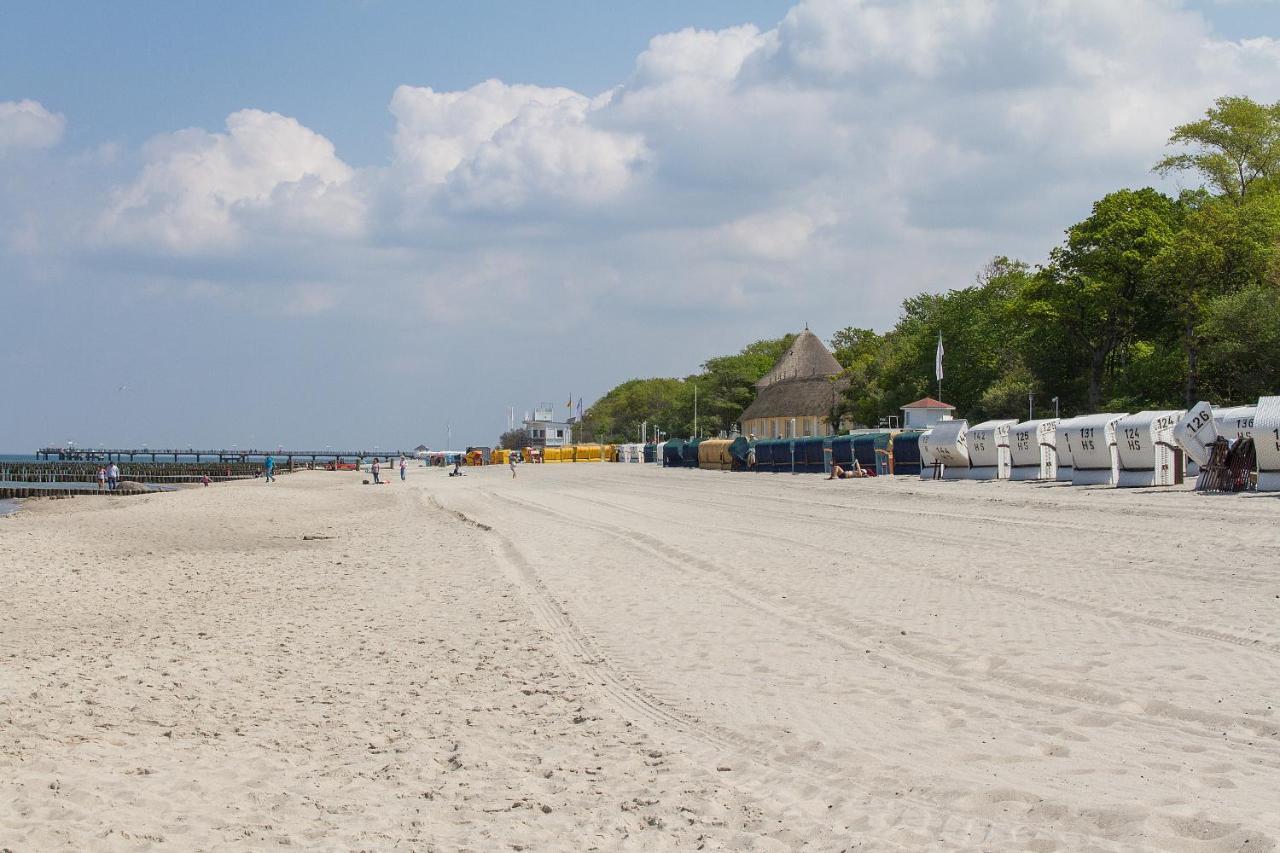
[742,328,849,438]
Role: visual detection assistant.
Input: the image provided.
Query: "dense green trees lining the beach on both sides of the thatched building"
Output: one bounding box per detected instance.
[588,97,1280,441]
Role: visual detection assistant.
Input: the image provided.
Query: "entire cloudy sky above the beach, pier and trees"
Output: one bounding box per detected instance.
[0,0,1280,452]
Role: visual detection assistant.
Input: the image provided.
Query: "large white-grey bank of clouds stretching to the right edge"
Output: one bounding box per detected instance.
[15,0,1280,324]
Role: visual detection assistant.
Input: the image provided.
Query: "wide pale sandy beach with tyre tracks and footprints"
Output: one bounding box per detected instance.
[0,465,1280,852]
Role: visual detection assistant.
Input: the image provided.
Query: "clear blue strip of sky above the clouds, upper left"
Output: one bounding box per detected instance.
[0,0,791,164]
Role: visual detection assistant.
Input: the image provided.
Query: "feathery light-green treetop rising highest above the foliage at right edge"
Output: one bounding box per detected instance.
[1156,97,1280,202]
